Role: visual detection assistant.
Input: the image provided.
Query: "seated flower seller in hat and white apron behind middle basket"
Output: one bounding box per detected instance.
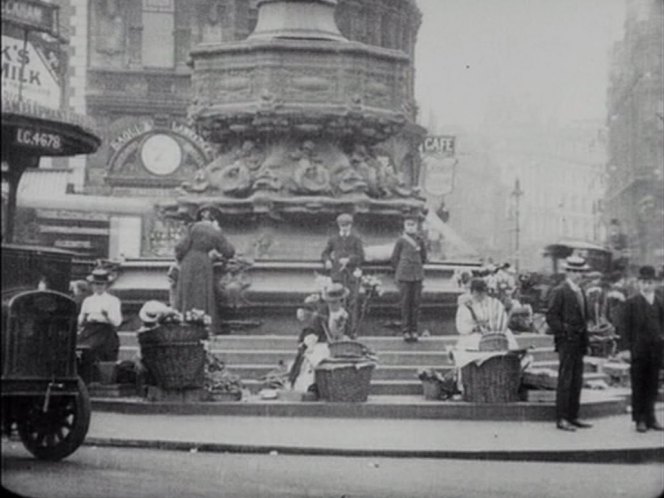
[288,283,350,392]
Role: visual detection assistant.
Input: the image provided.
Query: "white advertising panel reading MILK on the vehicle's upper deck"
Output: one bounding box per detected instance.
[2,35,62,109]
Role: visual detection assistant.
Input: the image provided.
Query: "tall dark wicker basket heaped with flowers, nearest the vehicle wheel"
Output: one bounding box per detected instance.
[138,302,210,389]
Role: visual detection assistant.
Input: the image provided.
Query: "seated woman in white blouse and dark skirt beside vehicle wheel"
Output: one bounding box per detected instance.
[78,269,122,361]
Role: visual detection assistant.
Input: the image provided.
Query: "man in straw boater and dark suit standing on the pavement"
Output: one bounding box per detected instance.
[546,256,592,431]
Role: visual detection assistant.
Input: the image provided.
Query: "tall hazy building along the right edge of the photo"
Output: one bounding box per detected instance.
[605,0,664,265]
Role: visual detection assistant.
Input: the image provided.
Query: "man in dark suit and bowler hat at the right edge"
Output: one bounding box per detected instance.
[623,266,664,432]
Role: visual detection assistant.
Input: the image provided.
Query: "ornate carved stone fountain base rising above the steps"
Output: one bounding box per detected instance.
[137,0,472,334]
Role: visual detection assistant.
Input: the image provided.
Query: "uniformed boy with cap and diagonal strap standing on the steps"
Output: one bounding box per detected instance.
[392,214,427,342]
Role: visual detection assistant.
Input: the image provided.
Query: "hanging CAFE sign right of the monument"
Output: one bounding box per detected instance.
[420,135,458,197]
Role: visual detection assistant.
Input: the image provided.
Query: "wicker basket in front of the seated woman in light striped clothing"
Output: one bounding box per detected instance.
[461,353,521,403]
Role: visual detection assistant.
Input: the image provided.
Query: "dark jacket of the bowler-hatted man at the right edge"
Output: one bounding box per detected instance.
[623,293,664,356]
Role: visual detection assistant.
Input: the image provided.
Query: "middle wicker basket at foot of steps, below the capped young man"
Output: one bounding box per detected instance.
[316,360,376,402]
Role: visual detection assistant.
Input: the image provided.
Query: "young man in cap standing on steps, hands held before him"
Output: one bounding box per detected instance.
[321,213,364,335]
